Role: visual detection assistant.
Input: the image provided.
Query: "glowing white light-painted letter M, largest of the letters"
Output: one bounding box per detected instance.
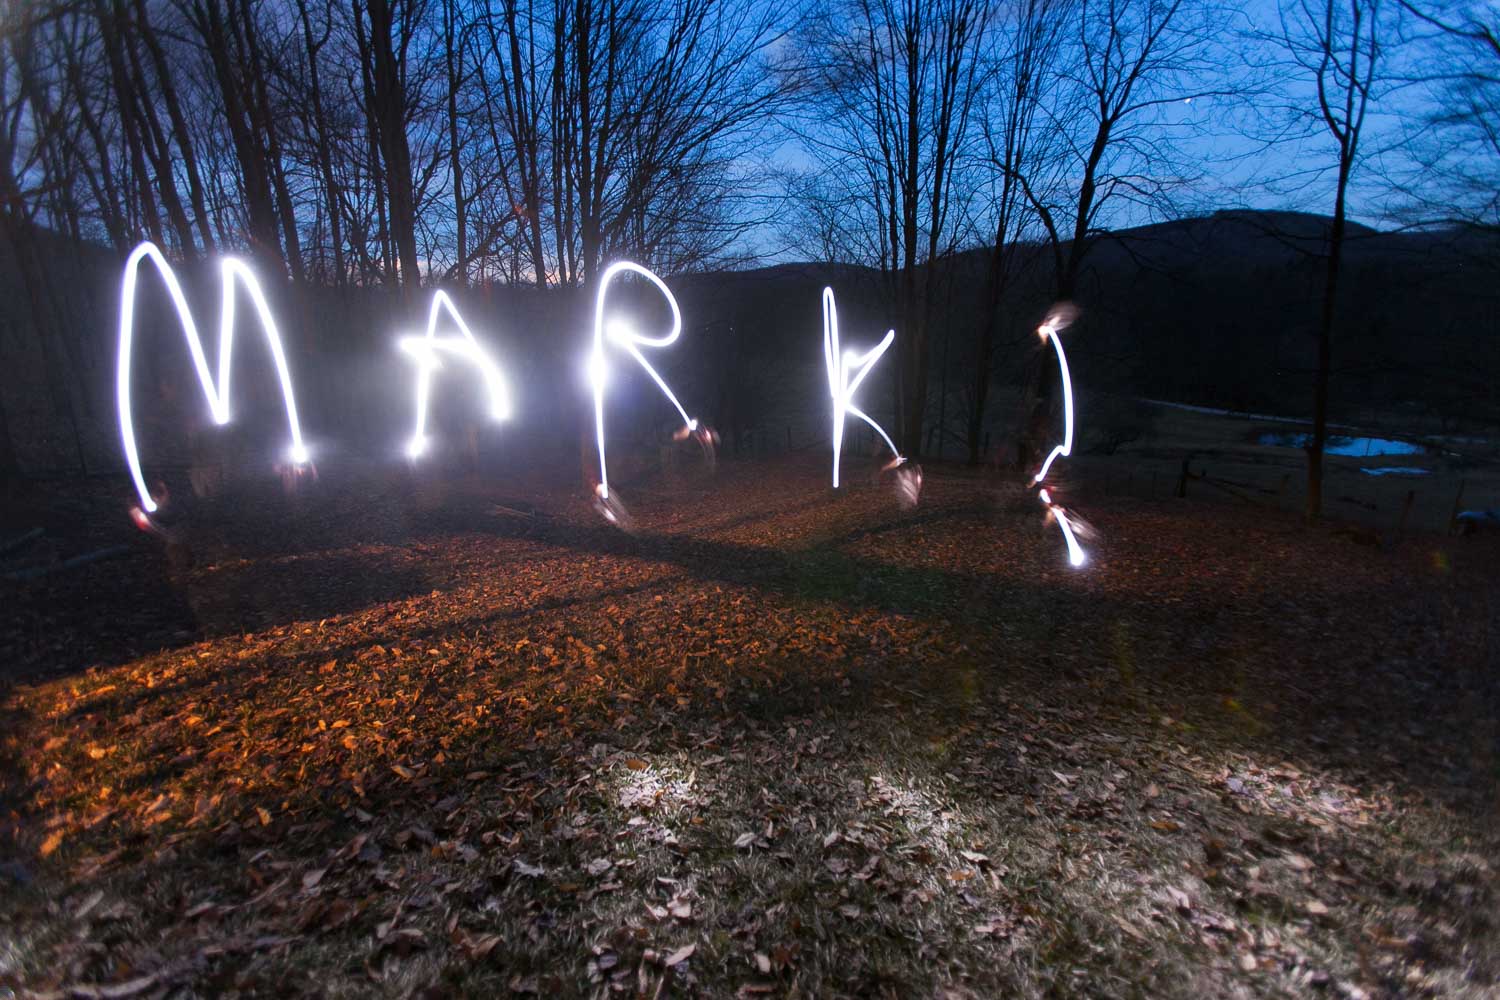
[114,241,311,514]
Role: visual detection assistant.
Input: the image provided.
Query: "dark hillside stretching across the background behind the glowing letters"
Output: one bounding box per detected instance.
[0,210,1500,471]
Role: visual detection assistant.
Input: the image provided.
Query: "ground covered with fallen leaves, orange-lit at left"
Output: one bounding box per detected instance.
[0,457,1500,997]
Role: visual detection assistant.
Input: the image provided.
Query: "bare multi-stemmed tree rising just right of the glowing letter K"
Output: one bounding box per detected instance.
[798,0,987,457]
